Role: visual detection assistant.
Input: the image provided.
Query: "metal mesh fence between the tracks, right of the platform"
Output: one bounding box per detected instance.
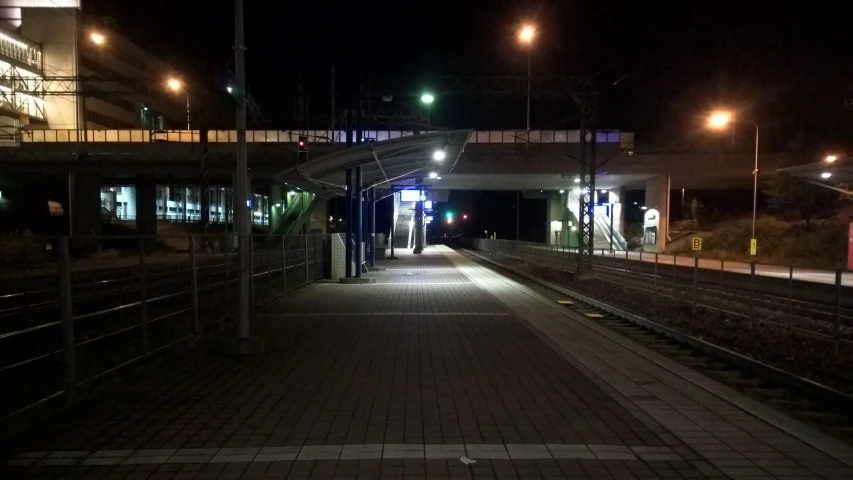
[461,238,853,355]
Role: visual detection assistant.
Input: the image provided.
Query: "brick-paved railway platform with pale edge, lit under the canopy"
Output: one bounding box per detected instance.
[0,246,853,480]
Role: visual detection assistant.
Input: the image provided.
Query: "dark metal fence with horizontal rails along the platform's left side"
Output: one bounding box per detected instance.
[0,233,330,419]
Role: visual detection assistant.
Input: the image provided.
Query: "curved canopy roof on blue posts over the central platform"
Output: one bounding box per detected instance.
[274,130,472,197]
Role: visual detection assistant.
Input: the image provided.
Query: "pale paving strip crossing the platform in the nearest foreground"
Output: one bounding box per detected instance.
[6,443,682,466]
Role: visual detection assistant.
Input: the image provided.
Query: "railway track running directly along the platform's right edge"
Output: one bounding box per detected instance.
[464,250,853,443]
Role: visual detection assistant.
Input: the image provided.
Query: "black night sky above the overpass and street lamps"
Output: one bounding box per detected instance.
[86,0,853,151]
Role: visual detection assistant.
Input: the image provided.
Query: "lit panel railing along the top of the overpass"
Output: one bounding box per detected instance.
[10,129,634,148]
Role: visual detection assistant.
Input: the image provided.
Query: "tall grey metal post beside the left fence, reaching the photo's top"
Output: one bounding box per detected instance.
[234,0,251,341]
